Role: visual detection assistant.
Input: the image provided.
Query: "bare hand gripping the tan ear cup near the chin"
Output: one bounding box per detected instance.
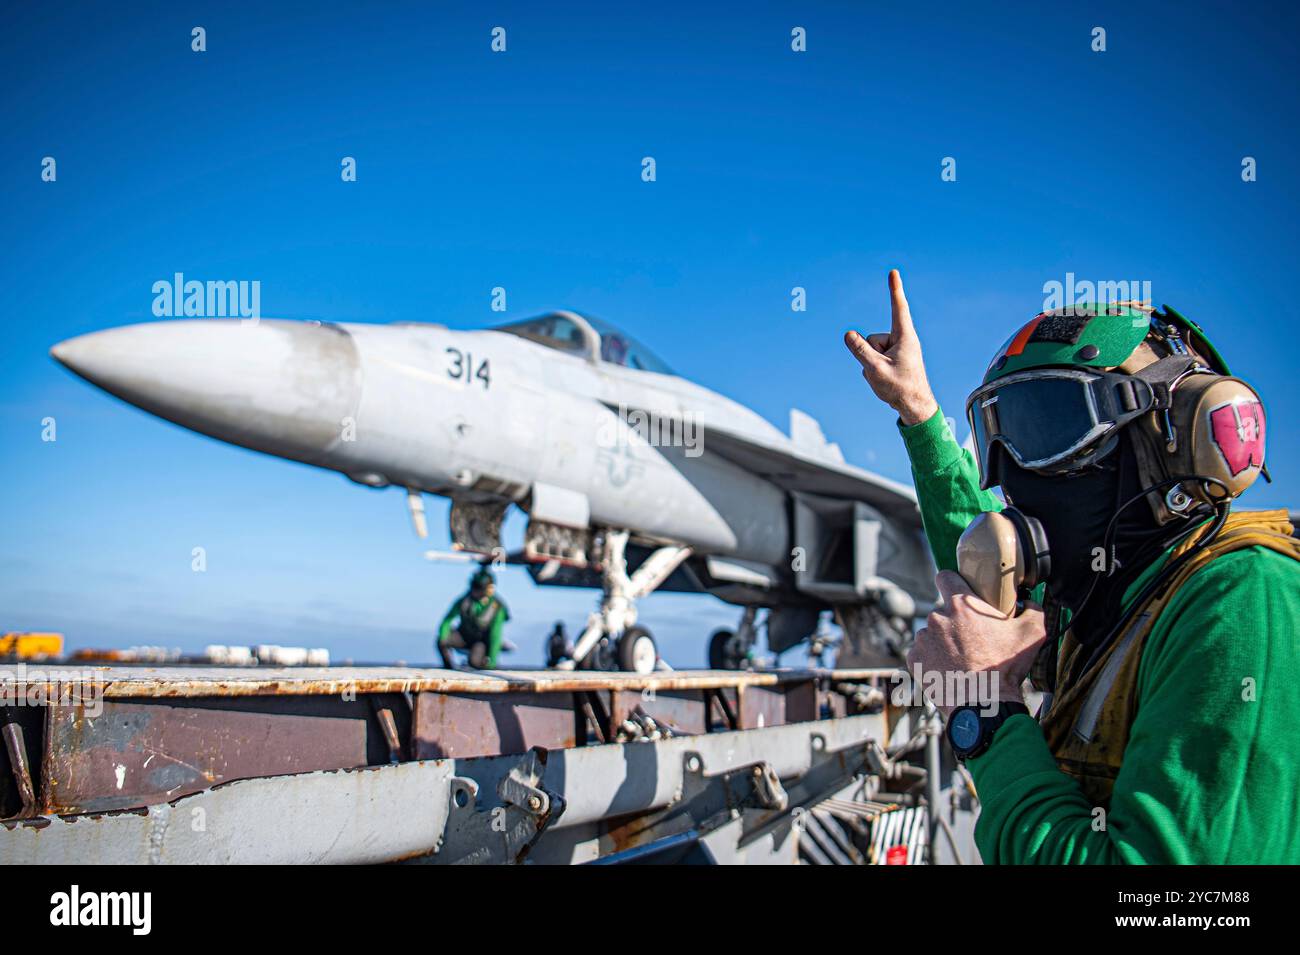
[907,570,1047,717]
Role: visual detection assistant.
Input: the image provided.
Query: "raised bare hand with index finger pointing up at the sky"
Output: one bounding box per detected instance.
[844,269,939,425]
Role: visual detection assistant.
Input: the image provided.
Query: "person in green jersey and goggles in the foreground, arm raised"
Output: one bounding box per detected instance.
[845,272,1300,863]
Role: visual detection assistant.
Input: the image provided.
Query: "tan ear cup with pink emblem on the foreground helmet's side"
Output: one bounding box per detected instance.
[1170,374,1265,504]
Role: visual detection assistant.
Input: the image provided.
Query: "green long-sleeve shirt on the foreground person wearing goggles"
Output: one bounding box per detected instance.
[900,412,1300,863]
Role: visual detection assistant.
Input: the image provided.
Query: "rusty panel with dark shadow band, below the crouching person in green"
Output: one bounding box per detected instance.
[412,693,577,759]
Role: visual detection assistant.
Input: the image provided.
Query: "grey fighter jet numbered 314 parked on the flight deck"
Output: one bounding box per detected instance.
[52,312,935,672]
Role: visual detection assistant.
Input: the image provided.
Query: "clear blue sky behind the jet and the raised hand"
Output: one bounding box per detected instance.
[0,3,1300,665]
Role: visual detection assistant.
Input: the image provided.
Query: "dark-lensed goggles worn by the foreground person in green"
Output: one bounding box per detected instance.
[966,368,1157,489]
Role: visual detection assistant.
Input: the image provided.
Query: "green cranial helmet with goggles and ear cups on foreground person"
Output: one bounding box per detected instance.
[966,303,1268,524]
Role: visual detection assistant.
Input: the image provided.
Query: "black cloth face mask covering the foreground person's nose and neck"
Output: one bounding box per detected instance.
[1002,437,1164,643]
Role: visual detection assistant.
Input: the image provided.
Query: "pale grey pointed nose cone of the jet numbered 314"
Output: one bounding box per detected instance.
[49,320,361,461]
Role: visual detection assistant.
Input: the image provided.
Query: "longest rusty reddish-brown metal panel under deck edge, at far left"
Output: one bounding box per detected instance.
[40,700,367,812]
